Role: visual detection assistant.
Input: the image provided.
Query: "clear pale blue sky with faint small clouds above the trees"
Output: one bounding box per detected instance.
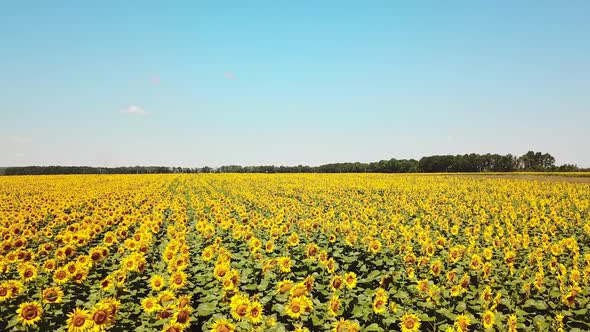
[0,1,590,167]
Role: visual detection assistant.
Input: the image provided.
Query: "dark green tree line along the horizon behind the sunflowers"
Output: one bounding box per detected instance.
[0,151,590,175]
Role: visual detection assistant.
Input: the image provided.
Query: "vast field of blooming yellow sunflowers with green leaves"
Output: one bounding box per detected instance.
[0,174,590,332]
